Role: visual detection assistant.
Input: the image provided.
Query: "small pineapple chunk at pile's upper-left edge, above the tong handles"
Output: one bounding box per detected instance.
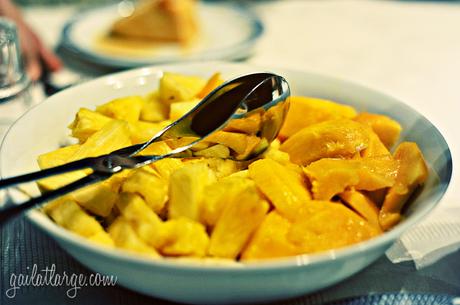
[69,108,113,143]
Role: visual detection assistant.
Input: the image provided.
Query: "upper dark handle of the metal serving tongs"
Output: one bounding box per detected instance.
[0,157,98,190]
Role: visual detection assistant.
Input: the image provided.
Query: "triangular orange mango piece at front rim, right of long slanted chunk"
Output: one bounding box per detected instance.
[241,211,300,261]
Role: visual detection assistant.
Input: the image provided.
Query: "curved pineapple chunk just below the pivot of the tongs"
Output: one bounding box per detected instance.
[121,167,168,214]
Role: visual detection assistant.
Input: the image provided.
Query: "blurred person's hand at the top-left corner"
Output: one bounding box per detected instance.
[0,0,61,81]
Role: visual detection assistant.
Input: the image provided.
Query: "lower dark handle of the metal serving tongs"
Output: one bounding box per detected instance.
[0,173,112,226]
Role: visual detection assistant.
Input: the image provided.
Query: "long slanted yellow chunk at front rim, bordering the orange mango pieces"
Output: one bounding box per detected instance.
[209,188,269,258]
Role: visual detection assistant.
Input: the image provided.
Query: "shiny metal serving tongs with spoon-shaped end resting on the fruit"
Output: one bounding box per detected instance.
[0,73,290,223]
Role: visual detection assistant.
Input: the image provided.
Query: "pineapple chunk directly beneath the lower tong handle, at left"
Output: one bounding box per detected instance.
[69,182,117,217]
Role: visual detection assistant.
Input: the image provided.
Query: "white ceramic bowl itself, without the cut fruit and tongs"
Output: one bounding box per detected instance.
[0,62,452,304]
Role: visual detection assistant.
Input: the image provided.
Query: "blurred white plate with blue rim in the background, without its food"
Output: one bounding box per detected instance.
[61,2,263,68]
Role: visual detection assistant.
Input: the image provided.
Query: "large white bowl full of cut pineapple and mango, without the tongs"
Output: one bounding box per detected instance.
[0,62,452,304]
